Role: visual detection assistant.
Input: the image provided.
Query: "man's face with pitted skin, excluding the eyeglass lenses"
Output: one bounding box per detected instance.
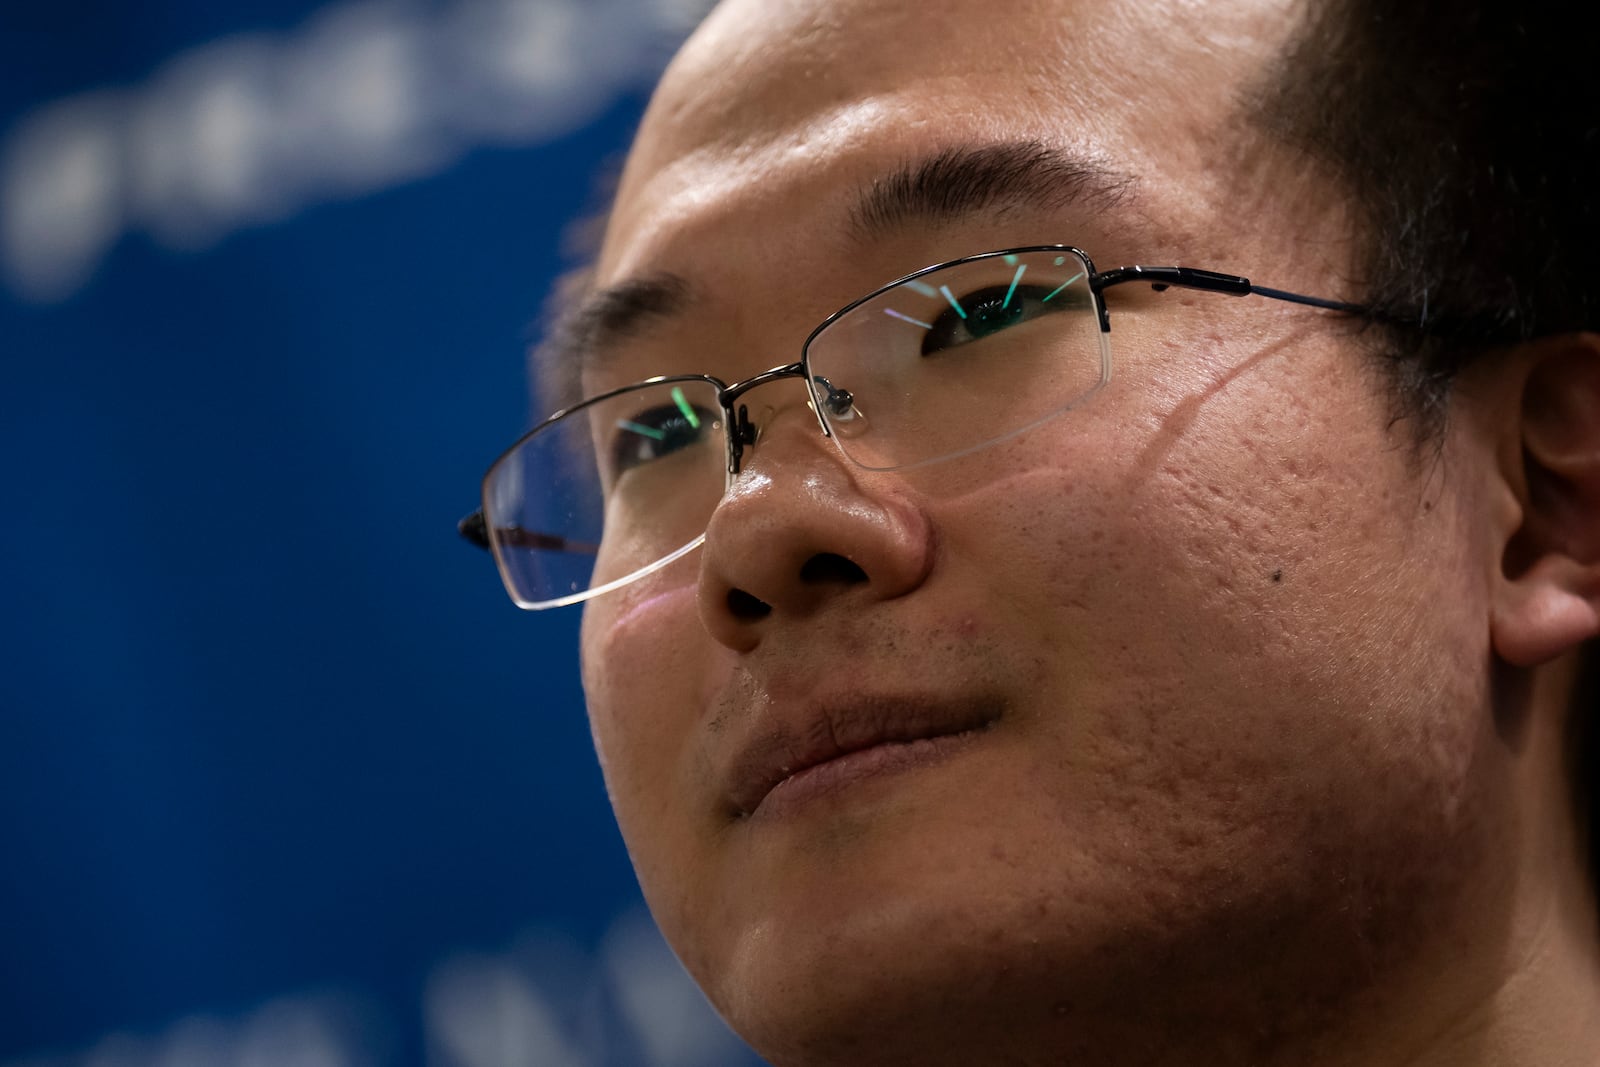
[582,0,1502,1062]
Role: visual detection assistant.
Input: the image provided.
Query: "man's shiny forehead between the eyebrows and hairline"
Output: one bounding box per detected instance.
[598,0,1290,282]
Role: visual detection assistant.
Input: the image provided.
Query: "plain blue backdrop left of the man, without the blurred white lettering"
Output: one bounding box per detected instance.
[0,0,761,1064]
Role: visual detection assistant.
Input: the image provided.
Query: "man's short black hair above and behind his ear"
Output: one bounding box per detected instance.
[1258,0,1600,886]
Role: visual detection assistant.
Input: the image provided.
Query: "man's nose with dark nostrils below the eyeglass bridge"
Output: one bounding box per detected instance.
[698,418,934,653]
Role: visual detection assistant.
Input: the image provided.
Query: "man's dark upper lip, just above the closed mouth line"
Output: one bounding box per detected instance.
[728,694,1000,816]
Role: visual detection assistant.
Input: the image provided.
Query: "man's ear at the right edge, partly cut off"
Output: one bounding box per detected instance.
[1491,333,1600,667]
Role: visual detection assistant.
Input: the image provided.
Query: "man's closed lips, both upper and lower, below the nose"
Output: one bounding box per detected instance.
[728,696,1000,816]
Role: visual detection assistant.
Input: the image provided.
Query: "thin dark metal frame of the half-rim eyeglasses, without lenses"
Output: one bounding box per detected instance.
[456,245,1368,579]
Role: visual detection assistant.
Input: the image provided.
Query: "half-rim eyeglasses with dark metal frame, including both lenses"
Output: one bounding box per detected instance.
[458,245,1362,609]
